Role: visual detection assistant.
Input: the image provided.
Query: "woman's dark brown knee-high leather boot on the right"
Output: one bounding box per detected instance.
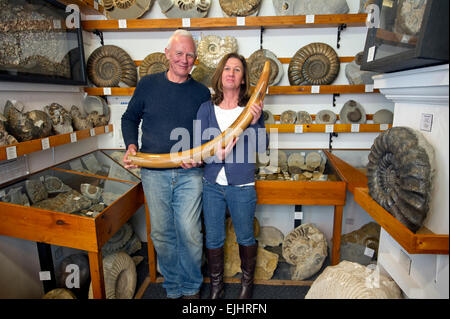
[239,243,258,299]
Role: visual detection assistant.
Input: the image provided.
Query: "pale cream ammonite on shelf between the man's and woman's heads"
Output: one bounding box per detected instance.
[197,35,238,68]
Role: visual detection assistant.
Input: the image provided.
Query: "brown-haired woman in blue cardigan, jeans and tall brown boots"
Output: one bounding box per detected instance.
[197,53,267,299]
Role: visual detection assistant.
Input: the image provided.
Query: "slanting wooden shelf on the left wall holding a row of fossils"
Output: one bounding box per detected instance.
[0,124,113,161]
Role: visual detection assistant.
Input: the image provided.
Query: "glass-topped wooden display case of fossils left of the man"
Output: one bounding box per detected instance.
[0,151,145,298]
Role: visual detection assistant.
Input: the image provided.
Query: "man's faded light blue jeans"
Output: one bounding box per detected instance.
[141,168,203,298]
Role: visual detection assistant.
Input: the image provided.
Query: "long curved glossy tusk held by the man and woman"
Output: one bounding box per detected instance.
[128,61,270,168]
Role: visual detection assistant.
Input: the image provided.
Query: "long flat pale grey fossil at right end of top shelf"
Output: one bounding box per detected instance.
[272,0,350,15]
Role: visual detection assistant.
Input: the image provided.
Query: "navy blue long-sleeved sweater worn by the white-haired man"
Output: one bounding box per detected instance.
[122,72,211,158]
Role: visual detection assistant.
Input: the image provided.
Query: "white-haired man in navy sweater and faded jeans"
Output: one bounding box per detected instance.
[122,30,210,298]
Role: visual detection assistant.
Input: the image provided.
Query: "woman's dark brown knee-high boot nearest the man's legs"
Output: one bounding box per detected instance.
[206,247,224,299]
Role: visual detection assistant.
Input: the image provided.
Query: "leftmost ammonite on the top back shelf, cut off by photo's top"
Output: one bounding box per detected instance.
[103,0,154,19]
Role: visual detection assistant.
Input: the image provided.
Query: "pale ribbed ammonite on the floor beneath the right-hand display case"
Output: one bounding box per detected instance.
[283,224,328,280]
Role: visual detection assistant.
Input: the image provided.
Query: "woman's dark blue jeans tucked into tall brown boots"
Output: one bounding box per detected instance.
[203,178,256,249]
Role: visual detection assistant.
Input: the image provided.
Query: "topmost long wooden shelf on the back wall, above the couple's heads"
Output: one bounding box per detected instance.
[82,13,367,32]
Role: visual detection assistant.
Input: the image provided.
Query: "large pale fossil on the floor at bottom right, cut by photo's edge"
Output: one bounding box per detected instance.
[305,261,402,299]
